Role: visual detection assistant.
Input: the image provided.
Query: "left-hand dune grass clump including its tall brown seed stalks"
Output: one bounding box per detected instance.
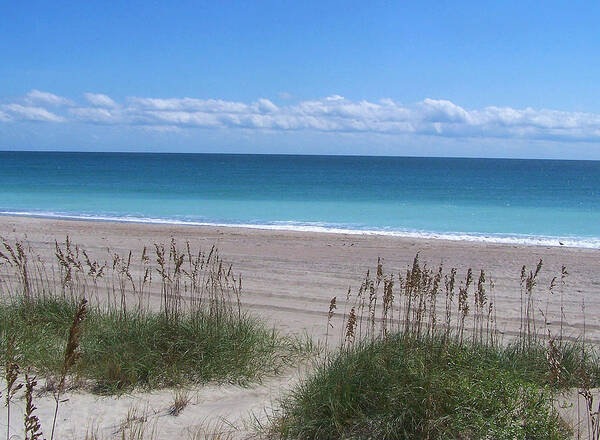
[0,239,307,395]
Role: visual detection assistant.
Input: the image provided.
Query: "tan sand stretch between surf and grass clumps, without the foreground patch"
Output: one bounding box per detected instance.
[0,216,600,342]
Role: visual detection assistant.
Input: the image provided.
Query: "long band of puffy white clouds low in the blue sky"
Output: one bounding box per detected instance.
[0,90,600,142]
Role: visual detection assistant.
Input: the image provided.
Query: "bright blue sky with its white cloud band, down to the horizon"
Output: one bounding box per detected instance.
[0,0,600,159]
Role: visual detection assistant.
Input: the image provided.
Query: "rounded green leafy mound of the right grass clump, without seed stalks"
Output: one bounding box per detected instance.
[272,335,569,440]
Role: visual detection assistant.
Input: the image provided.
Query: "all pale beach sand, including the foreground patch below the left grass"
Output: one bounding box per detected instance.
[0,216,600,438]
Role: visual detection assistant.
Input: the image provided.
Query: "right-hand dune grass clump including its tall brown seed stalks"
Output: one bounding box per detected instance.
[269,254,600,440]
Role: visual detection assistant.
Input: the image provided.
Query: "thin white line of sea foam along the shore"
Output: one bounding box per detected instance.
[0,211,600,249]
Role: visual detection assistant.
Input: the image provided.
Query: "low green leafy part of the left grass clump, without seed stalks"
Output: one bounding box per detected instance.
[0,298,301,393]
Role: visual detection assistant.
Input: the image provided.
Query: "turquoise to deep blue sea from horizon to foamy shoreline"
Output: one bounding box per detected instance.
[0,152,600,247]
